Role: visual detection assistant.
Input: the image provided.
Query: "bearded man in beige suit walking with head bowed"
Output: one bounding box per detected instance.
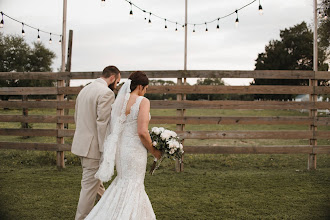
[71,66,120,220]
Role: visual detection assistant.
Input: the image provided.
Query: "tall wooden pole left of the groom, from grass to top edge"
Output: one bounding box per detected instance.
[56,0,67,168]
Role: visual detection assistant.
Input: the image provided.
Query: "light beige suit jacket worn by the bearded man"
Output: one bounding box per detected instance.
[71,78,115,159]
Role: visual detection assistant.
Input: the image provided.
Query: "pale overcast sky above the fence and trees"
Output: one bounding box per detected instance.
[0,0,313,86]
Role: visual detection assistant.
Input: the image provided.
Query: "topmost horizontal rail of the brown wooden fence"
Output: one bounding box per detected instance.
[0,70,330,80]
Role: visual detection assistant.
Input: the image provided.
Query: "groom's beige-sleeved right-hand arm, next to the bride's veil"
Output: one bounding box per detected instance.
[96,90,115,152]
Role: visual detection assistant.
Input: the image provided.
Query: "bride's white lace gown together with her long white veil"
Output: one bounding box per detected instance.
[85,80,156,220]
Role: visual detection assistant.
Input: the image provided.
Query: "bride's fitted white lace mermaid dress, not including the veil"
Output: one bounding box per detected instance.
[86,96,156,220]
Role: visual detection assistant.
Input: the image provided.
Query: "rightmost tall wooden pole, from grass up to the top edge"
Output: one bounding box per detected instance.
[307,0,318,170]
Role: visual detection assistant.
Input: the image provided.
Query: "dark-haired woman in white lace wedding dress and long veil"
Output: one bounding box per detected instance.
[85,71,161,220]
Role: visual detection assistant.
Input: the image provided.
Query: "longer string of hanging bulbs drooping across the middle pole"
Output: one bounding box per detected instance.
[113,0,263,32]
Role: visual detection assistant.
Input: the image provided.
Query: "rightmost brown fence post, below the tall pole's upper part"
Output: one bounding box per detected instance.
[307,71,318,170]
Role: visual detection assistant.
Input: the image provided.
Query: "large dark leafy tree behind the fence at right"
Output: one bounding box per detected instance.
[251,22,328,100]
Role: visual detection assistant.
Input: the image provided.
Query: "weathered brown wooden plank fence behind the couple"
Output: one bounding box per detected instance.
[0,70,330,169]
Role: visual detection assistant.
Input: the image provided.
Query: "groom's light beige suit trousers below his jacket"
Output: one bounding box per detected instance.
[75,157,105,220]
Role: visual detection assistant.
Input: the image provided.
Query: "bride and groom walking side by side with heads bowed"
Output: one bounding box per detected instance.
[71,66,161,220]
